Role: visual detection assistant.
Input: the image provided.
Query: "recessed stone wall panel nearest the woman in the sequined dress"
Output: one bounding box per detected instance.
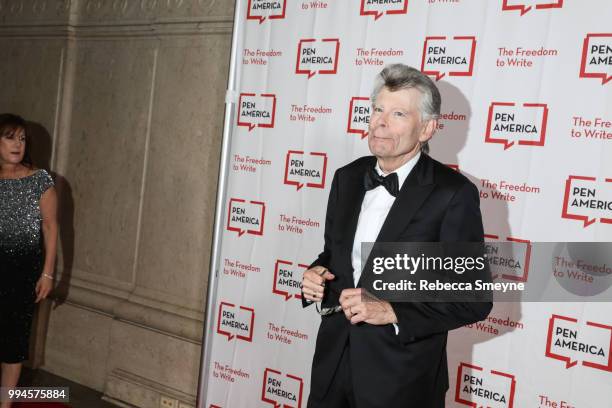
[62,41,156,283]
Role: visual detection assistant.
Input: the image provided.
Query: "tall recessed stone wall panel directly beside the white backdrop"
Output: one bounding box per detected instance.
[137,37,230,309]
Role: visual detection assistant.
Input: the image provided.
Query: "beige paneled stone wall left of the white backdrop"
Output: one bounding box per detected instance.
[0,0,234,407]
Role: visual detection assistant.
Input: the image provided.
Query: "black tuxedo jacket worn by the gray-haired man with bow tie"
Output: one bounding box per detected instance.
[303,153,492,408]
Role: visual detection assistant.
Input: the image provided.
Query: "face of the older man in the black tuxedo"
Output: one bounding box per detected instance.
[368,88,435,163]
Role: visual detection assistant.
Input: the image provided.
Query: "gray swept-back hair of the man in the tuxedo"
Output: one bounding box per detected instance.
[370,64,442,153]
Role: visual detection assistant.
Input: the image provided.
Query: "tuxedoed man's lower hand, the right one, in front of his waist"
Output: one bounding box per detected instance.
[340,288,397,325]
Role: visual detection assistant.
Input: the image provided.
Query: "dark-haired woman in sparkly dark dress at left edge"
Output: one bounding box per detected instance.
[0,114,57,408]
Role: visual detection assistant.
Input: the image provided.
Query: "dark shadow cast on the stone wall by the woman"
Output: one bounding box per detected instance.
[26,122,74,368]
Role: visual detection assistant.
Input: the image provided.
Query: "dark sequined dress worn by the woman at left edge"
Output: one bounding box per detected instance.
[0,170,53,363]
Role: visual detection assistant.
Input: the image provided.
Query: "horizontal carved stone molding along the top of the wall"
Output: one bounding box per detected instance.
[0,0,233,40]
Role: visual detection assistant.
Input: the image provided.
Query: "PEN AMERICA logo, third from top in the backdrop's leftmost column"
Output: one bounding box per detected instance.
[227,198,266,237]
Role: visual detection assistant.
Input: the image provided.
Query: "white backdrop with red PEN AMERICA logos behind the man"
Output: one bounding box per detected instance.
[205,0,612,408]
